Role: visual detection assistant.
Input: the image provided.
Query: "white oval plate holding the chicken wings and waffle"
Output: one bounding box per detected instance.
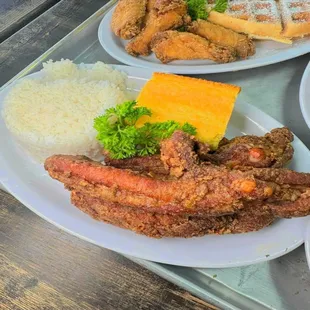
[98,8,310,74]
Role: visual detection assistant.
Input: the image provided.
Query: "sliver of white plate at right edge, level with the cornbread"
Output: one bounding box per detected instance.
[299,62,310,128]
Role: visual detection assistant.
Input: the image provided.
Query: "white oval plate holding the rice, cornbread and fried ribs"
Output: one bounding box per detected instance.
[0,66,310,268]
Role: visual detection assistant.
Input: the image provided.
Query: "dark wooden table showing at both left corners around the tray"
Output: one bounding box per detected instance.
[0,0,217,310]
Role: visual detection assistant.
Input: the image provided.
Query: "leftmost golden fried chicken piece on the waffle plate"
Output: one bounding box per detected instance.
[111,0,147,40]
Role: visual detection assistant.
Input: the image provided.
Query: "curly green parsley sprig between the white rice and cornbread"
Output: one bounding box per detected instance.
[94,101,196,159]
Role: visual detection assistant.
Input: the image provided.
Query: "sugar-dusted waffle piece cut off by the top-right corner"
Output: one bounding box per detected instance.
[279,0,310,38]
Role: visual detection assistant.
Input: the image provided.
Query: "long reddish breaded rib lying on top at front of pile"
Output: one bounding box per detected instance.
[45,147,310,216]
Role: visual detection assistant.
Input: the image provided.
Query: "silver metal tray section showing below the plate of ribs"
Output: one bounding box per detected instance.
[134,246,310,310]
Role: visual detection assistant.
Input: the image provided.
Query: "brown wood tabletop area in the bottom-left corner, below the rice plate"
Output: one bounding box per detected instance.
[0,191,217,310]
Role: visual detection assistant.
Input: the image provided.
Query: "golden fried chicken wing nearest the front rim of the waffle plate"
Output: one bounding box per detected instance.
[151,30,236,63]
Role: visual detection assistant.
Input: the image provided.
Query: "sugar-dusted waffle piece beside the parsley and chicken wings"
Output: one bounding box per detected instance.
[208,0,292,43]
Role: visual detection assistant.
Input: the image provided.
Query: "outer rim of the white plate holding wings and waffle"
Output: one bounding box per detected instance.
[98,5,310,74]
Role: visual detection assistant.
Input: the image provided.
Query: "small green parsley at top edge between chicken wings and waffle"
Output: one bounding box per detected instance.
[186,0,228,20]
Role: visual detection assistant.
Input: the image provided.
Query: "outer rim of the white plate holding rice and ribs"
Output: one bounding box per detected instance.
[0,65,309,268]
